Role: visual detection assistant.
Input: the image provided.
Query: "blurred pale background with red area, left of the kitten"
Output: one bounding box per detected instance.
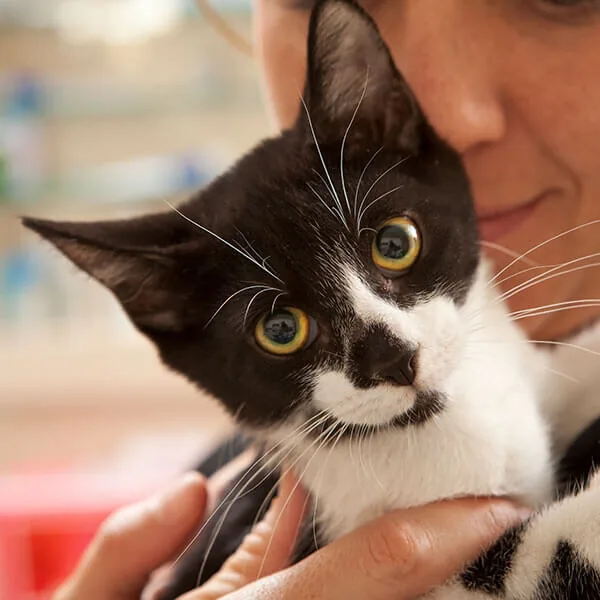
[0,0,268,600]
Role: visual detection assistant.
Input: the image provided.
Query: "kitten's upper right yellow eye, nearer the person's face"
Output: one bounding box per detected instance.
[372,217,421,277]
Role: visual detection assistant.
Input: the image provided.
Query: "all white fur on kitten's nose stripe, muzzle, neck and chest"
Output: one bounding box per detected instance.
[270,262,553,540]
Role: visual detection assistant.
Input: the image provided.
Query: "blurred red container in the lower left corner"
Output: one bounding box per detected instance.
[0,471,168,600]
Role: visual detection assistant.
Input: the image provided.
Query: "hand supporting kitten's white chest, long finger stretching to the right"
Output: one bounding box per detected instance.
[180,488,529,600]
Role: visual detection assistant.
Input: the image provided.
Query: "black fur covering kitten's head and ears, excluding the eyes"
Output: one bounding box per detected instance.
[24,0,479,436]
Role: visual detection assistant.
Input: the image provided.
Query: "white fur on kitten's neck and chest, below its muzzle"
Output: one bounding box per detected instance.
[264,270,553,541]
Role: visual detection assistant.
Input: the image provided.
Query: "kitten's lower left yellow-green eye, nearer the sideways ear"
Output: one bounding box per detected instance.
[254,307,311,356]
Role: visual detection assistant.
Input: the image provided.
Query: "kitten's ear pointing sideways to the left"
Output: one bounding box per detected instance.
[23,213,196,333]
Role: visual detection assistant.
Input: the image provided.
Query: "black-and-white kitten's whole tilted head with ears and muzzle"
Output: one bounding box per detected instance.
[25,0,479,440]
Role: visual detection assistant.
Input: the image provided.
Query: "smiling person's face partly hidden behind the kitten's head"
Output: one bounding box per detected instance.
[255,0,600,339]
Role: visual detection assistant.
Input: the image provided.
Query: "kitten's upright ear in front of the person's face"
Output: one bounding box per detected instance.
[300,0,424,154]
